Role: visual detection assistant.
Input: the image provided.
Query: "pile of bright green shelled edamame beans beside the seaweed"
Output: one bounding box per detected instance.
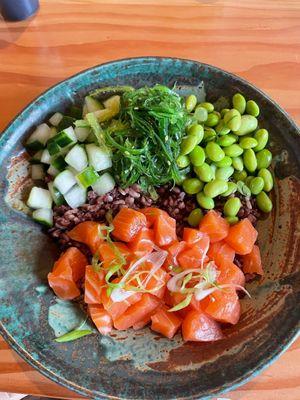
[183,93,274,226]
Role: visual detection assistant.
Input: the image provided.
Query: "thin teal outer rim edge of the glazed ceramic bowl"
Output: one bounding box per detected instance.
[0,56,300,400]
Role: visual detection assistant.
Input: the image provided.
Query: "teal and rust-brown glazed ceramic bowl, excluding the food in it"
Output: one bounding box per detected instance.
[0,57,300,400]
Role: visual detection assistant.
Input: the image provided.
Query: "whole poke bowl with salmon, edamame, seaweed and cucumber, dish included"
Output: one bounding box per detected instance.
[0,57,300,399]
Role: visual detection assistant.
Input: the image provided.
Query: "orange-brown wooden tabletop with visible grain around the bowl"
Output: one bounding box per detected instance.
[0,0,300,400]
